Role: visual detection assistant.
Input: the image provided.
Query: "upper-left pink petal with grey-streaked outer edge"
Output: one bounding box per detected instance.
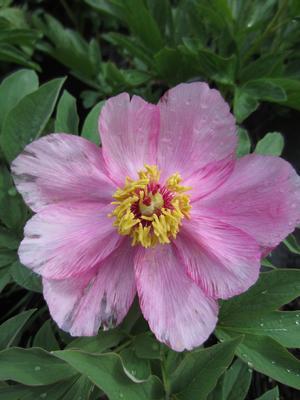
[11,134,115,212]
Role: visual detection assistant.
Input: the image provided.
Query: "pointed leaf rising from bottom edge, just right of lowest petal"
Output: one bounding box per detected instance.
[170,338,241,400]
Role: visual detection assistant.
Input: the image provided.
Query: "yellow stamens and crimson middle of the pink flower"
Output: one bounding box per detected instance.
[109,165,191,247]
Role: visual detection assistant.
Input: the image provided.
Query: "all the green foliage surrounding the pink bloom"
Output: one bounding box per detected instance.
[0,0,300,400]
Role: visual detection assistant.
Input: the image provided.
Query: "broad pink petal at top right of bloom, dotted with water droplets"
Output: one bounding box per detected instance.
[157,82,237,179]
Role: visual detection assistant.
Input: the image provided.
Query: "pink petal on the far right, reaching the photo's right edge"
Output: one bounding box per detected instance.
[199,154,300,248]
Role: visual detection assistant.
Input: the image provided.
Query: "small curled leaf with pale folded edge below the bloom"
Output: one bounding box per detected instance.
[120,347,151,383]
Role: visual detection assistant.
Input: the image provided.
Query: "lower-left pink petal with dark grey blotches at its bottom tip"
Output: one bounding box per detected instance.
[43,240,136,336]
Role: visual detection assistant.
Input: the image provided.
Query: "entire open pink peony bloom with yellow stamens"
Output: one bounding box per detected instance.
[12,83,300,351]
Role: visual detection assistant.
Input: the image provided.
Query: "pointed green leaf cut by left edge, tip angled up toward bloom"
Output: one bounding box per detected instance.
[0,309,36,350]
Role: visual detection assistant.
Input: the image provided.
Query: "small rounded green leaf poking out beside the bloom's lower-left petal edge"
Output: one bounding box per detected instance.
[10,261,42,293]
